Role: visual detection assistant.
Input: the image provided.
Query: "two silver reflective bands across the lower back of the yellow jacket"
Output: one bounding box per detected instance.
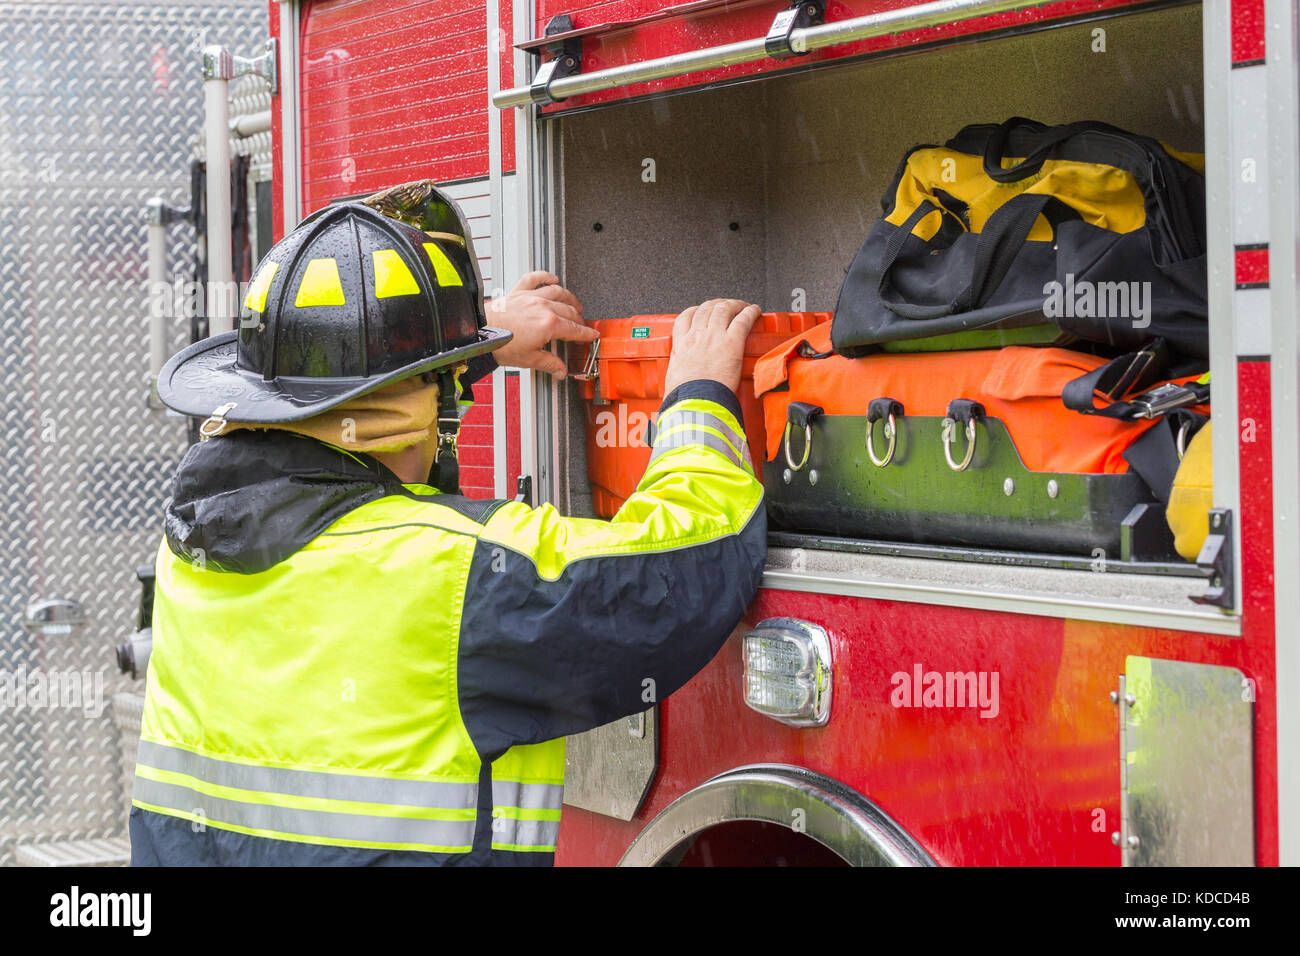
[133,740,478,852]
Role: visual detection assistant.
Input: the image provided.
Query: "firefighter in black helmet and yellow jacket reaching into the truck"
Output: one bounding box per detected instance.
[130,196,766,865]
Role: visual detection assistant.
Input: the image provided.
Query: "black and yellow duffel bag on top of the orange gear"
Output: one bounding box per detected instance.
[831,117,1209,359]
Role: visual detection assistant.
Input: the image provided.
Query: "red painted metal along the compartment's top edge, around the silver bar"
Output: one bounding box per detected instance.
[534,0,1170,112]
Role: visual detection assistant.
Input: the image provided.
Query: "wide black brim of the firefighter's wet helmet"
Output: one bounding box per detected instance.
[157,328,514,425]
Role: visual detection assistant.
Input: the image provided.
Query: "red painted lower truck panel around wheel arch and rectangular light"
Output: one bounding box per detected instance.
[558,591,1277,866]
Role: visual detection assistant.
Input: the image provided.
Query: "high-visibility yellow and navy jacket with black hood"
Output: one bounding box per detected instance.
[131,381,766,865]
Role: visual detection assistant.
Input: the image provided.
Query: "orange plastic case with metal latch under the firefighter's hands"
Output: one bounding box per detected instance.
[582,312,831,518]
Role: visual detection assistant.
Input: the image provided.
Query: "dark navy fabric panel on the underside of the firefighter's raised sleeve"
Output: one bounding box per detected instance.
[459,506,767,758]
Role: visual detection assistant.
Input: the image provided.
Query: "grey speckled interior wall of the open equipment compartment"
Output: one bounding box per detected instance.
[556,4,1204,512]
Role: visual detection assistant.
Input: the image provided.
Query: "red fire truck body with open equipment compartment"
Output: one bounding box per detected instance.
[258,0,1300,866]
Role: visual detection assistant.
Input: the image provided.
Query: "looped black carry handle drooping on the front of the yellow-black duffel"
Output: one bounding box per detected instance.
[880,193,1080,319]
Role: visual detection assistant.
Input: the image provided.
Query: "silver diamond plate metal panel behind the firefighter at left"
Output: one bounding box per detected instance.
[0,0,267,865]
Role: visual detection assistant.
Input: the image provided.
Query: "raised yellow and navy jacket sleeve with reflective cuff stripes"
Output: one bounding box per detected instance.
[458,381,767,753]
